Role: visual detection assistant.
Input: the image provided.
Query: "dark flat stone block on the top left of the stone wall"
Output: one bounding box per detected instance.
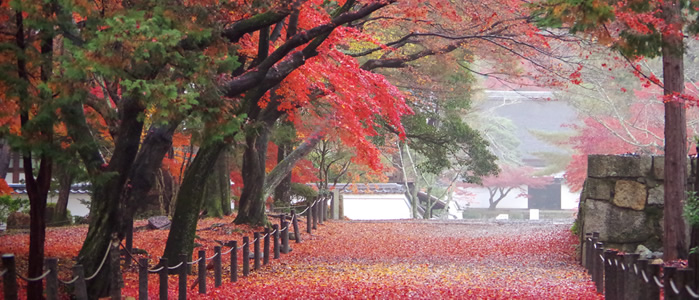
[588,154,652,178]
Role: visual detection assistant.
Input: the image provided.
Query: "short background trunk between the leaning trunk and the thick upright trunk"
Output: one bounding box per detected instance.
[202,151,231,218]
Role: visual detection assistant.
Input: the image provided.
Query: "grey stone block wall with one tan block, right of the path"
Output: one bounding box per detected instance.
[576,155,698,252]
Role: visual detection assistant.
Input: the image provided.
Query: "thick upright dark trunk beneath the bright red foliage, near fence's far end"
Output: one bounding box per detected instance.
[234,122,270,226]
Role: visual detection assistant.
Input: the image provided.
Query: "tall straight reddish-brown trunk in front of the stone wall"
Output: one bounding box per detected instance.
[661,0,688,261]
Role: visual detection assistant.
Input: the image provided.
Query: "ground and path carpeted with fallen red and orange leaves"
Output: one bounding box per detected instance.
[0,217,603,299]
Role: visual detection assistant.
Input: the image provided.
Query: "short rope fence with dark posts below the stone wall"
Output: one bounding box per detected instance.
[581,232,698,300]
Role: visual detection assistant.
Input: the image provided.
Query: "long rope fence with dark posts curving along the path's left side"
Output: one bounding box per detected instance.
[0,198,328,300]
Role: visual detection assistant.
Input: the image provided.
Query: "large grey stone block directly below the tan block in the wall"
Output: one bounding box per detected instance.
[583,200,653,244]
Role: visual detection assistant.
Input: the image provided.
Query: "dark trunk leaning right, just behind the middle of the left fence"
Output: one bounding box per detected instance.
[163,141,226,266]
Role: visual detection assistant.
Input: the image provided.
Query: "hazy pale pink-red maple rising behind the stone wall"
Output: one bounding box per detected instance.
[555,42,698,190]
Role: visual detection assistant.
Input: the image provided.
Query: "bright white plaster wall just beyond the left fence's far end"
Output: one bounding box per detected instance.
[343,194,411,220]
